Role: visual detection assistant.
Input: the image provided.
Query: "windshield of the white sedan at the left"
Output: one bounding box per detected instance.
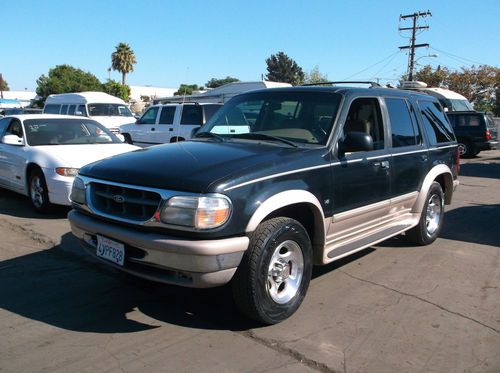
[24,119,121,146]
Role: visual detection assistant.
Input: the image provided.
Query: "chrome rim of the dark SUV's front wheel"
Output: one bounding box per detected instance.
[267,240,304,304]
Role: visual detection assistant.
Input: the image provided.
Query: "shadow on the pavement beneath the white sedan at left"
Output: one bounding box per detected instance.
[0,188,70,219]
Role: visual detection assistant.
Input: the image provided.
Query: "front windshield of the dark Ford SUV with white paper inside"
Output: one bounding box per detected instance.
[199,90,341,145]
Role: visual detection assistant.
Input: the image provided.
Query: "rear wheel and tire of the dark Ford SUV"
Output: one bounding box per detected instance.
[406,181,444,246]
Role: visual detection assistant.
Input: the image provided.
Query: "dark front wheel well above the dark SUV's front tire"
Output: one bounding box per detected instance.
[262,203,325,264]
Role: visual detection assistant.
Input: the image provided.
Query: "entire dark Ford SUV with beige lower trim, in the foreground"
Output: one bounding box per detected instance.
[68,87,459,324]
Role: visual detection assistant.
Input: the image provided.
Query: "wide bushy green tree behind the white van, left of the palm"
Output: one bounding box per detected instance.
[36,65,103,102]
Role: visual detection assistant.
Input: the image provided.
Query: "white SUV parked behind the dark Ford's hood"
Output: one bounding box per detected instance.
[120,103,222,146]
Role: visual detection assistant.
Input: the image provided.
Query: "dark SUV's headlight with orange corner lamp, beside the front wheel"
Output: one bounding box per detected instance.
[160,196,231,229]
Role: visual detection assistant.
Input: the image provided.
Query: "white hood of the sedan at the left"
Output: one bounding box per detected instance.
[31,144,140,168]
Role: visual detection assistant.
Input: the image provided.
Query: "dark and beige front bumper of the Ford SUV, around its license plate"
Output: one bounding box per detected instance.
[68,210,250,288]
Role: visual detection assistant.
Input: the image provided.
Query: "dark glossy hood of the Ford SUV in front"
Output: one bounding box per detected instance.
[80,141,307,193]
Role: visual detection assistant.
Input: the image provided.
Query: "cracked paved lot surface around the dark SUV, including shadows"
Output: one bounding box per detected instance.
[0,151,500,372]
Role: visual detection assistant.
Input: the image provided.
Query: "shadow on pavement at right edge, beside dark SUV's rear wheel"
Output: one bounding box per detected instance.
[440,203,500,247]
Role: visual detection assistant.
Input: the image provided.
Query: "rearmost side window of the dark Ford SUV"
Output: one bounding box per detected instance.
[418,101,455,145]
